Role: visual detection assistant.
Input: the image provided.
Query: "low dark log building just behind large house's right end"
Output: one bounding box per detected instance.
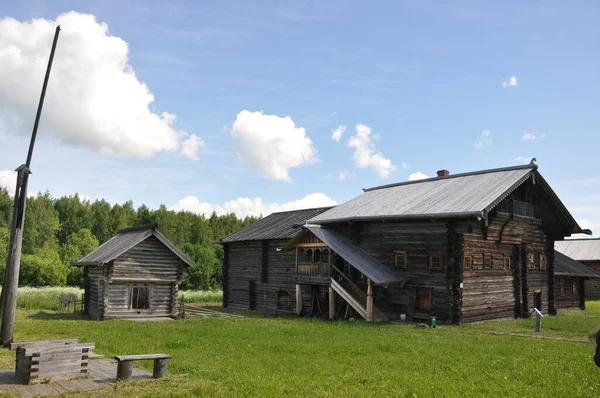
[554,250,600,310]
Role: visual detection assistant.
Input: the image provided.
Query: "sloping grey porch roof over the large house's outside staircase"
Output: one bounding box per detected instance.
[284,225,406,285]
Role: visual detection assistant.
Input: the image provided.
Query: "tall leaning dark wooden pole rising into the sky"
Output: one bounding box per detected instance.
[0,26,60,346]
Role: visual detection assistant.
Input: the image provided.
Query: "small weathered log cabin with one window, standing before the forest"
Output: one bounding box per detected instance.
[73,225,196,320]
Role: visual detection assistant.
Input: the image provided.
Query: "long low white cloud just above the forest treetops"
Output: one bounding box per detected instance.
[170,193,337,218]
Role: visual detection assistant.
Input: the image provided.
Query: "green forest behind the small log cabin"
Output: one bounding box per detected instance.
[0,188,259,289]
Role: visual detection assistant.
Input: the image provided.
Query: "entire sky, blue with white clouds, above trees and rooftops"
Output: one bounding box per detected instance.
[0,0,600,236]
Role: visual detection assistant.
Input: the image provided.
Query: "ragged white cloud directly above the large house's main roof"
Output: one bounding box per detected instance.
[348,124,397,178]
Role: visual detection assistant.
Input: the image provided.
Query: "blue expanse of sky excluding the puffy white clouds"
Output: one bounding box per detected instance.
[0,1,600,233]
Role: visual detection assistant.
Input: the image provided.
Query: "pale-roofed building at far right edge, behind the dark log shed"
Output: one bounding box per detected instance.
[556,239,600,298]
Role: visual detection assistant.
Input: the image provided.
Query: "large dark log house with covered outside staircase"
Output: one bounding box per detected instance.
[221,163,591,325]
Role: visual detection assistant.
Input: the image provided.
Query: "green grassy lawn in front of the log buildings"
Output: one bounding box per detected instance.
[0,301,600,397]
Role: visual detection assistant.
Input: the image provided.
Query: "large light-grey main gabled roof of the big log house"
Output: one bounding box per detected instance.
[308,163,587,233]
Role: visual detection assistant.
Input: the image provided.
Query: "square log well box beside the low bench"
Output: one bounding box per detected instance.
[9,339,95,384]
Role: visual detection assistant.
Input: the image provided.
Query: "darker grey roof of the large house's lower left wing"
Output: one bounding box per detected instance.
[220,207,331,243]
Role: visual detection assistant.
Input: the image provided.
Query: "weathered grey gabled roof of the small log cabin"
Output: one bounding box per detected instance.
[73,224,196,267]
